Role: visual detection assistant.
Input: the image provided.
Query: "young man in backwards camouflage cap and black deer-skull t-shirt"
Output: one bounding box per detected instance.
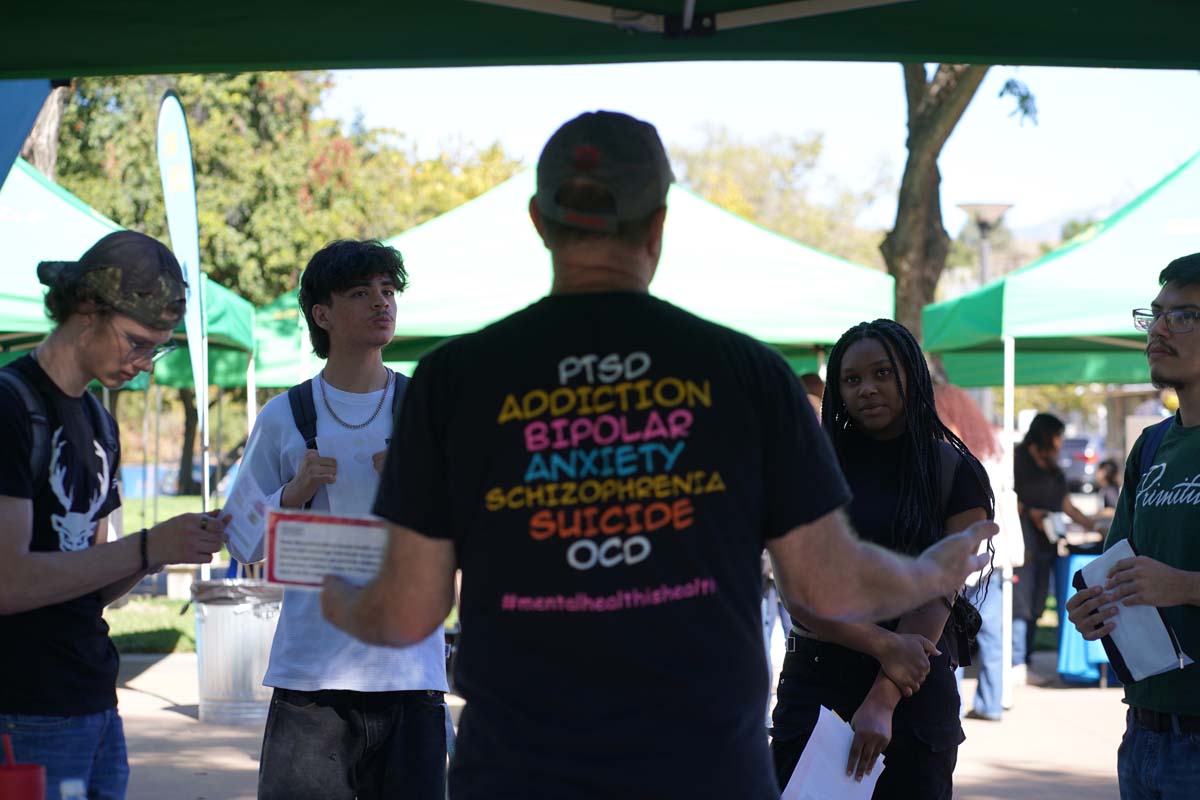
[0,230,224,800]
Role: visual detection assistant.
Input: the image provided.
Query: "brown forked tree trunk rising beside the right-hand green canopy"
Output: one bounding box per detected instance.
[880,64,988,339]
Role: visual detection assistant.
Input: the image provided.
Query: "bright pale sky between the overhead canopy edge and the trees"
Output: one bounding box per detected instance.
[324,62,1200,236]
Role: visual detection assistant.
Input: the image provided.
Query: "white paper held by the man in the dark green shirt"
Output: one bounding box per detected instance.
[1080,539,1192,680]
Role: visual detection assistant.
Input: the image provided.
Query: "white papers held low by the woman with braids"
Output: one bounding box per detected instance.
[780,706,883,800]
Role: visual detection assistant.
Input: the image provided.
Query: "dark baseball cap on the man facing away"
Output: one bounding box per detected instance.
[535,112,674,233]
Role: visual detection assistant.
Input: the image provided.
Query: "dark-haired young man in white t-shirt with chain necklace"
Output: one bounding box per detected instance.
[226,241,448,800]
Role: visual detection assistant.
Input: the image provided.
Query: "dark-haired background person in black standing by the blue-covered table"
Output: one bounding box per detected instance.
[1013,414,1096,682]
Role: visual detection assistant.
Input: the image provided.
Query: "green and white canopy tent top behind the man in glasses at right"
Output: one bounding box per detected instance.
[922,154,1200,386]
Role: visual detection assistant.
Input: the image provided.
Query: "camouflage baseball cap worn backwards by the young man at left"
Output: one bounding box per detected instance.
[37,230,187,331]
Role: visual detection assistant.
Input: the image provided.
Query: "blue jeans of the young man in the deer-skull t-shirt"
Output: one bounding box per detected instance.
[0,709,130,800]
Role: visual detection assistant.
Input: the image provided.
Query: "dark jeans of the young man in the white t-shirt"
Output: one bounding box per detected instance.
[258,688,446,800]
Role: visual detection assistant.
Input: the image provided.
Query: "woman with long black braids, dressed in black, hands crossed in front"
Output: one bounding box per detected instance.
[772,319,994,800]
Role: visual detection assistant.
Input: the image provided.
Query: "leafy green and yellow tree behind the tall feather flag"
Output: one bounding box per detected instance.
[56,72,520,303]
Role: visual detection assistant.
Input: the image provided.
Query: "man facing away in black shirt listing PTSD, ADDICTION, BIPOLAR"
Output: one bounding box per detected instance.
[323,112,992,799]
